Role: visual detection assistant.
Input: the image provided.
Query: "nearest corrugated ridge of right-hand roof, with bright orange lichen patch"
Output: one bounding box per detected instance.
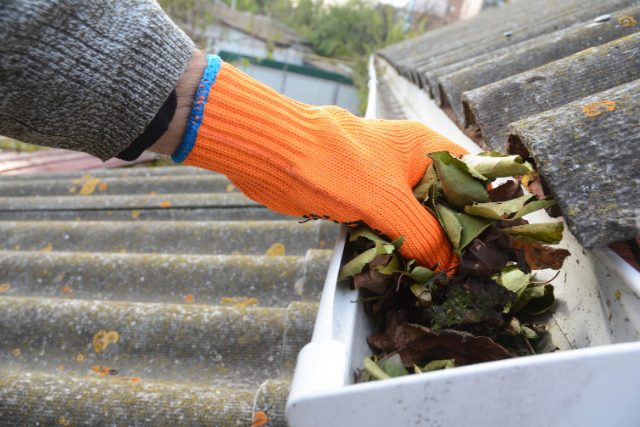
[508,79,640,248]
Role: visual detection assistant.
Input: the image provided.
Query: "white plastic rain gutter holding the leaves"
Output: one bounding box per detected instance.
[286,55,640,427]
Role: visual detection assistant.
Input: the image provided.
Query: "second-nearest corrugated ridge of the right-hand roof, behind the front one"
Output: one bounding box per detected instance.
[462,34,640,151]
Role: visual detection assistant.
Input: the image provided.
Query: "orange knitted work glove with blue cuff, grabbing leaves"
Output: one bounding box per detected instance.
[173,56,468,269]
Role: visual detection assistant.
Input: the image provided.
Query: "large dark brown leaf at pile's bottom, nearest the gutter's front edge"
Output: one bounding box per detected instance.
[367,323,513,367]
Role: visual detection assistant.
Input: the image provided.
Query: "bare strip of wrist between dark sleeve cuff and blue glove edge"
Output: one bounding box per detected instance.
[149,49,207,156]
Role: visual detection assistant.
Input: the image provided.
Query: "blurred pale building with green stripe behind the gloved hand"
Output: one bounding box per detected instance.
[185,1,359,114]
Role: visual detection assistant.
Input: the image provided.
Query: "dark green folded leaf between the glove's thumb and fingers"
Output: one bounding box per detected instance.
[428,151,489,209]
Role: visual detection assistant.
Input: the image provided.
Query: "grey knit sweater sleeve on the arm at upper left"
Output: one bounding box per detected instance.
[0,0,193,160]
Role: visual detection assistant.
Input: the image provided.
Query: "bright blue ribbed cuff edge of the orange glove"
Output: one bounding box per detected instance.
[171,55,222,163]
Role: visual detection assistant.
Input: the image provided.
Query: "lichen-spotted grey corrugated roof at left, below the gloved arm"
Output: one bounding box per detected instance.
[0,167,337,427]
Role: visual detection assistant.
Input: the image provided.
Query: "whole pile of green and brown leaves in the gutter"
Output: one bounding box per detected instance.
[338,151,570,381]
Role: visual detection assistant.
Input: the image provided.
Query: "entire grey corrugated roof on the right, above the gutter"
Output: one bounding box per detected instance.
[378,0,640,256]
